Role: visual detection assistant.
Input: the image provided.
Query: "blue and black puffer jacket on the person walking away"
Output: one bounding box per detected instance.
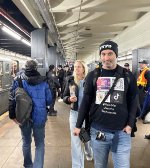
[9,70,52,125]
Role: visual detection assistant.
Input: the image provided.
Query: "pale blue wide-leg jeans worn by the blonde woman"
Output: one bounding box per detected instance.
[69,110,92,168]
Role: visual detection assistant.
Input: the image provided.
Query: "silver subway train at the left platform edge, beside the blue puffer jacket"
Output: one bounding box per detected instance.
[0,49,31,115]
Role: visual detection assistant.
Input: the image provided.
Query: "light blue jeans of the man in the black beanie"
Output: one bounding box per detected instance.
[91,128,131,168]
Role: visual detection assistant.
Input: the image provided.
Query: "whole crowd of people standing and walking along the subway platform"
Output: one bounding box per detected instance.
[9,41,150,168]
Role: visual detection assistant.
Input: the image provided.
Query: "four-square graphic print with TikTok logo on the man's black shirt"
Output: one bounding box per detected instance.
[95,77,124,104]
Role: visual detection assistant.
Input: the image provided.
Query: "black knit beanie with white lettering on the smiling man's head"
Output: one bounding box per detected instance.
[99,41,118,57]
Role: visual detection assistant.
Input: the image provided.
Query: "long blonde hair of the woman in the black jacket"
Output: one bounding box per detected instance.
[73,60,88,85]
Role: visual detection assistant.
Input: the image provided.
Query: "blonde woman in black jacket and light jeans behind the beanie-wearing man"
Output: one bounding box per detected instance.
[63,60,93,168]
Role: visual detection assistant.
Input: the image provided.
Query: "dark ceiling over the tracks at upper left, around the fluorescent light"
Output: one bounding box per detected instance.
[0,0,34,56]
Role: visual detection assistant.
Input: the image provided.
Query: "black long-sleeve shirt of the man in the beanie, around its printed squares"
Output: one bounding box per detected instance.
[76,66,137,130]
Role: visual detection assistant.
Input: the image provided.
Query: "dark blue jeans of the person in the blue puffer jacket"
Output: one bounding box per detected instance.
[20,122,45,168]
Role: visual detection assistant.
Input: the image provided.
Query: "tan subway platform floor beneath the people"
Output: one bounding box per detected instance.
[0,100,150,168]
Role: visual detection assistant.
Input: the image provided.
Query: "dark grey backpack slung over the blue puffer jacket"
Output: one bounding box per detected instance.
[15,78,32,124]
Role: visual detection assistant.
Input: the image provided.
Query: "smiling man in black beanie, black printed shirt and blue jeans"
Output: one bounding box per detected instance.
[73,41,137,168]
